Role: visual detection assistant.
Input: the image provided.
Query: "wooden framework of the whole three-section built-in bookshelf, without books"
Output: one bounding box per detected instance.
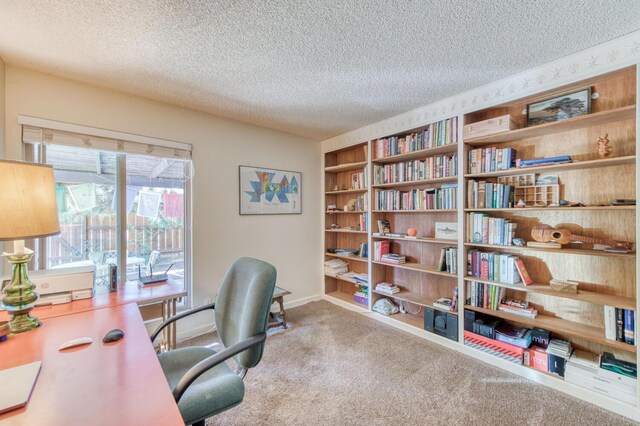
[324,67,640,418]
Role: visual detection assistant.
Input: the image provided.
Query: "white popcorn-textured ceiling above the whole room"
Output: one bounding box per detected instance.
[0,0,640,139]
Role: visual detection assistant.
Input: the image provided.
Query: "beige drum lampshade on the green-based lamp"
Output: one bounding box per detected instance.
[0,160,60,241]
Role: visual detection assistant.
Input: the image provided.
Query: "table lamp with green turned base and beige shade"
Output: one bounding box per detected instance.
[0,160,60,334]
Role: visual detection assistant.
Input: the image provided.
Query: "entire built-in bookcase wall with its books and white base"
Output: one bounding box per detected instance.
[325,67,640,420]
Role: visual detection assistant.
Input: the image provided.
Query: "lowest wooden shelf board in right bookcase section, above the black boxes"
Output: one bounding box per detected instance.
[464,305,636,352]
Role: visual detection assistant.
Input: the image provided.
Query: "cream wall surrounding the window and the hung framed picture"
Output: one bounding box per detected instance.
[0,66,322,335]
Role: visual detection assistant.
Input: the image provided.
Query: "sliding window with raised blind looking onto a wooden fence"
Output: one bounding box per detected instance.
[23,117,191,296]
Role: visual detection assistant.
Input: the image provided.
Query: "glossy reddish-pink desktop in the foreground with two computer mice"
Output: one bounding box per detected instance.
[0,303,183,426]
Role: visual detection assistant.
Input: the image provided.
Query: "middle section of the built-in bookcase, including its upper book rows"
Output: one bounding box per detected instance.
[371,117,459,330]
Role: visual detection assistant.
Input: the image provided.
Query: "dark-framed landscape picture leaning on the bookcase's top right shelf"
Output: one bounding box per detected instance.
[527,87,591,127]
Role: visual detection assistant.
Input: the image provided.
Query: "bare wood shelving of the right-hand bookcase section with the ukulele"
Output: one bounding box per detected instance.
[461,68,637,370]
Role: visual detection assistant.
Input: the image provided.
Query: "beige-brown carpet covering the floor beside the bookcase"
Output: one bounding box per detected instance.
[184,301,634,426]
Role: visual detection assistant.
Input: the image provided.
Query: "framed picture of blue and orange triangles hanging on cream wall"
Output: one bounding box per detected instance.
[240,166,302,215]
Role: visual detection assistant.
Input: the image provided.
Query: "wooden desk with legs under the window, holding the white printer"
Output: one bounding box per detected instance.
[0,279,187,351]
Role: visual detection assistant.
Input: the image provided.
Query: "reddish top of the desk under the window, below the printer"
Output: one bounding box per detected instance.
[0,279,187,321]
